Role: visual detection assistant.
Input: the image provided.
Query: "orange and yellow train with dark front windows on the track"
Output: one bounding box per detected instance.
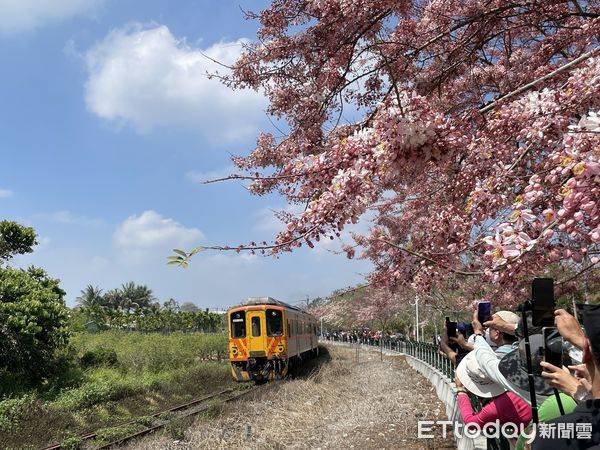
[227,297,318,381]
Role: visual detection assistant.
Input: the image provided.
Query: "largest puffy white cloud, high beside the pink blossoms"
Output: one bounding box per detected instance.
[85,24,266,141]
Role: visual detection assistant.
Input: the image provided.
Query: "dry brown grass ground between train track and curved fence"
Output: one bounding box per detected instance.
[127,346,456,450]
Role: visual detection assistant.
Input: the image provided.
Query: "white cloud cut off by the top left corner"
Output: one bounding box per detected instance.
[0,0,104,34]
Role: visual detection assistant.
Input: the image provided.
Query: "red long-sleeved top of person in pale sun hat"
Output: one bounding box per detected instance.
[458,392,531,427]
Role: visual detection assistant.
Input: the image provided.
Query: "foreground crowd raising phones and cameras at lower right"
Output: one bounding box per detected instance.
[440,305,600,450]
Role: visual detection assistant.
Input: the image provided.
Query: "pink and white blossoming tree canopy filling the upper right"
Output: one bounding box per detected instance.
[196,0,600,306]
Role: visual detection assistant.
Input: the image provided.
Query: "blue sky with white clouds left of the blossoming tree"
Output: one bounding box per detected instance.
[0,0,371,308]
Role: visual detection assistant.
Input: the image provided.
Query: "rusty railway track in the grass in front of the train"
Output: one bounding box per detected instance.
[42,385,262,450]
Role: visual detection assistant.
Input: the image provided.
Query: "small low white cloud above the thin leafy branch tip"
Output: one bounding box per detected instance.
[113,210,204,250]
